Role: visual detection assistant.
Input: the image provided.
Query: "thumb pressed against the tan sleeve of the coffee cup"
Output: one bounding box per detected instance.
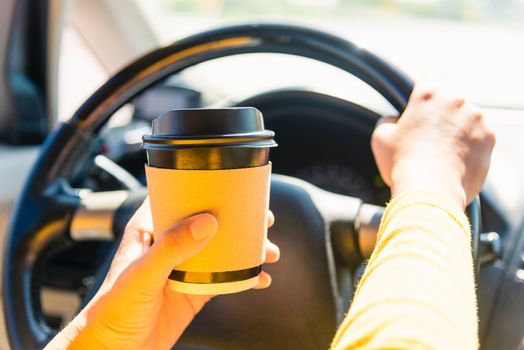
[130,213,218,291]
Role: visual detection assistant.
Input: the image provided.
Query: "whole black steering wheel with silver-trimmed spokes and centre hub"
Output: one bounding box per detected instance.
[2,24,479,349]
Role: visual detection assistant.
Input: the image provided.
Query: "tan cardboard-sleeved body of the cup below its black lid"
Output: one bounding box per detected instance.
[146,163,271,295]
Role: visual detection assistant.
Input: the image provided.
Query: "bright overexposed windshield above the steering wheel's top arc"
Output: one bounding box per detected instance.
[138,0,524,107]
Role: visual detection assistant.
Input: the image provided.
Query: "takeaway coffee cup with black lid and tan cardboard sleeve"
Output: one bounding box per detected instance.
[143,107,276,294]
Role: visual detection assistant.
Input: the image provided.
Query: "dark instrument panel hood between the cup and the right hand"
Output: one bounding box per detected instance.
[237,90,389,205]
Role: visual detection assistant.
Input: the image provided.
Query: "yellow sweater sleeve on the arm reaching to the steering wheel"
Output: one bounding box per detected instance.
[332,191,478,350]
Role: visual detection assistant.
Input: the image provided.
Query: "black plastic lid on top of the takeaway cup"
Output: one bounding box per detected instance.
[142,107,277,149]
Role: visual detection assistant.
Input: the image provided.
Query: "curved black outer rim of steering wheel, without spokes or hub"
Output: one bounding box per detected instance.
[2,24,478,349]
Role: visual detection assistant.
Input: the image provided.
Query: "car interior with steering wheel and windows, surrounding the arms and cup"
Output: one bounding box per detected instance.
[0,0,524,350]
